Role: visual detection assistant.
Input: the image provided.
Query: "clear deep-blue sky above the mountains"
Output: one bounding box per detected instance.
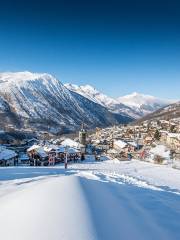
[0,0,180,99]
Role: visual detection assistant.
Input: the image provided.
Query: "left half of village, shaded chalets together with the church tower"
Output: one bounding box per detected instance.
[0,126,87,166]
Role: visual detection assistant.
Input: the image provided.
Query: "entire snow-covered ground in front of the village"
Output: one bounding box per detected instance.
[0,158,180,240]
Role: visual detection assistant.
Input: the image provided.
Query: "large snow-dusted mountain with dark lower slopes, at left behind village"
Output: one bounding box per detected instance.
[0,72,132,133]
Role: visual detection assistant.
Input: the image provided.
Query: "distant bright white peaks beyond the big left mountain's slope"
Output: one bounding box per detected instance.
[65,84,172,119]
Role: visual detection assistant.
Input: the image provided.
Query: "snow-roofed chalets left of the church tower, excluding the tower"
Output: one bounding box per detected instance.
[0,138,85,166]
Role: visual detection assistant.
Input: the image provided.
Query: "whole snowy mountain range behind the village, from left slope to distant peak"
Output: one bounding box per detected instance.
[0,72,176,132]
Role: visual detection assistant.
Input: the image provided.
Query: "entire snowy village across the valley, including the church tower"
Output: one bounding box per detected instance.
[0,119,180,168]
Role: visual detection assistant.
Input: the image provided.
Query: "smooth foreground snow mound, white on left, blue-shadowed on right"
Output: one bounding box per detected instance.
[0,175,180,240]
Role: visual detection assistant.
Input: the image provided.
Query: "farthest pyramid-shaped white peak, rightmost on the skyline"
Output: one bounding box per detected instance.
[118,92,173,116]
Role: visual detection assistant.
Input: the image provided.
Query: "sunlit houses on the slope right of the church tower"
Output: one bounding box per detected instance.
[90,119,180,165]
